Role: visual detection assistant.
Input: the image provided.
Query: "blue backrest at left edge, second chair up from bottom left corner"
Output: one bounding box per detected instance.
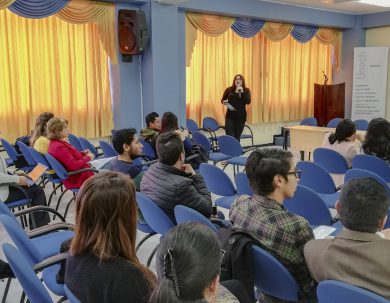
[0,214,43,266]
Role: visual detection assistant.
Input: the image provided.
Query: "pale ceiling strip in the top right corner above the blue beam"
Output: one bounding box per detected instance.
[261,0,390,14]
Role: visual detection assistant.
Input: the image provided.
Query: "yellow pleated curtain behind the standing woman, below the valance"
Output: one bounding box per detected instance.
[186,29,332,124]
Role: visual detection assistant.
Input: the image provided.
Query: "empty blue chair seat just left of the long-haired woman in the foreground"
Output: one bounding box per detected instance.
[31,230,74,259]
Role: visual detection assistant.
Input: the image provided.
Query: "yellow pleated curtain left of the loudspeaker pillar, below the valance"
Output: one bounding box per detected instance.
[0,10,113,140]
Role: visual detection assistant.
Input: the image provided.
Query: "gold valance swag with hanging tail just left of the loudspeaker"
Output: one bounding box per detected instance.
[56,0,118,64]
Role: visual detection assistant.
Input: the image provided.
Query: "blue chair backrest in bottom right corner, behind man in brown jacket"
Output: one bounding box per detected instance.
[317,280,390,303]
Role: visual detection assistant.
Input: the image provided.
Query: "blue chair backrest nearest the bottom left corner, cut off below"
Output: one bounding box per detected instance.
[2,243,53,303]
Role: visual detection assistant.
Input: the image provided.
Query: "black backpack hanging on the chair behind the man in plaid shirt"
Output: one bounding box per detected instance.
[217,227,260,302]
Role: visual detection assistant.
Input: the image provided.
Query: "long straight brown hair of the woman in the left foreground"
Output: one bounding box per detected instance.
[70,172,156,288]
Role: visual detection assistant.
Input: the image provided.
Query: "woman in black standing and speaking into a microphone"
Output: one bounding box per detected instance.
[221,75,251,141]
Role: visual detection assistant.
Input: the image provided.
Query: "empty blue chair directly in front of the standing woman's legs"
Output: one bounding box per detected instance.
[218,135,248,175]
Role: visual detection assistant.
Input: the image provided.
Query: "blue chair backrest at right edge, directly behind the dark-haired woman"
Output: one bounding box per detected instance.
[352,155,390,183]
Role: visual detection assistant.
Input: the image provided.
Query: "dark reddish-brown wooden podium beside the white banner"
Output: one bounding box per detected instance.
[314,83,345,126]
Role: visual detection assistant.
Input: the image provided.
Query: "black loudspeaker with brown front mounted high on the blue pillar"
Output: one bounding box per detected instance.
[118,9,149,55]
